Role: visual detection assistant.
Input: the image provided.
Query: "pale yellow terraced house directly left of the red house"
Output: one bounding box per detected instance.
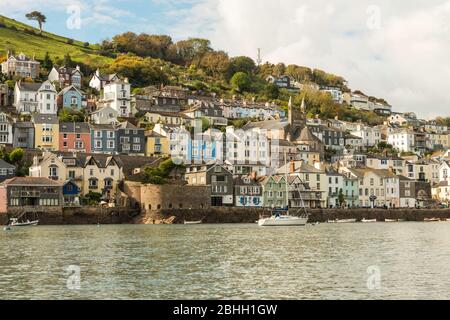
[32,114,59,151]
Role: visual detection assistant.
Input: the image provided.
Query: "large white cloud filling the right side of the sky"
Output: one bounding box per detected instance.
[172,0,450,117]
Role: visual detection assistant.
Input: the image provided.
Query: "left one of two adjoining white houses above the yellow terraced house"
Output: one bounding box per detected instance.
[14,81,41,114]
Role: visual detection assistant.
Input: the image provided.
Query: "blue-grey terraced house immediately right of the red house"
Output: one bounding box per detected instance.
[90,124,117,154]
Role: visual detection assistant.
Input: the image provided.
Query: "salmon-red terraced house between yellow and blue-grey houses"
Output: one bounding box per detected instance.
[59,122,91,153]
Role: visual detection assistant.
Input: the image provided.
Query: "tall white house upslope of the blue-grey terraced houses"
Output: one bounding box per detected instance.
[100,79,131,117]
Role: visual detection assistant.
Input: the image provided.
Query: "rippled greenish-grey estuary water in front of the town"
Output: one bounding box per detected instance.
[0,222,450,300]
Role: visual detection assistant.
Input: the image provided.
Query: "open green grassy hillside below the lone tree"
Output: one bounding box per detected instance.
[0,15,113,66]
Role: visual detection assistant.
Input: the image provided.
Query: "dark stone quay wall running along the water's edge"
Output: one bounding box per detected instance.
[0,207,450,225]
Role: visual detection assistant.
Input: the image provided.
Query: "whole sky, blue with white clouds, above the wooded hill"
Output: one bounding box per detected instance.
[0,0,450,118]
